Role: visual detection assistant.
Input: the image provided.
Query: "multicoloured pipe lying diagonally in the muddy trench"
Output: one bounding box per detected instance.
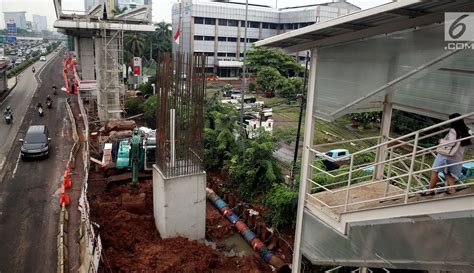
[206,188,291,273]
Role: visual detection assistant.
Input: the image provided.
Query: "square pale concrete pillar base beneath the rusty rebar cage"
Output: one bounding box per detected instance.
[153,165,206,240]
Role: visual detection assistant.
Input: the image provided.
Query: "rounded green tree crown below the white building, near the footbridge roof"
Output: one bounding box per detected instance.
[245,46,303,77]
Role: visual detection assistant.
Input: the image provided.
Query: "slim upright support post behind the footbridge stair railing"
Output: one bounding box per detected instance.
[373,93,393,180]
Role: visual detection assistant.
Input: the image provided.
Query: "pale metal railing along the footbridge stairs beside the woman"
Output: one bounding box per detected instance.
[307,112,474,212]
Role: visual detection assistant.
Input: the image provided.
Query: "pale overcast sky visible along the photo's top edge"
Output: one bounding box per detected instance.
[0,0,391,29]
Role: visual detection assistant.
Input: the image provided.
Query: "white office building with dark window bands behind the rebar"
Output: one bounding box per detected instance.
[172,0,360,77]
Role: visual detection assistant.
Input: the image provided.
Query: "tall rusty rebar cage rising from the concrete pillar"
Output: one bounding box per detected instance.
[156,53,206,177]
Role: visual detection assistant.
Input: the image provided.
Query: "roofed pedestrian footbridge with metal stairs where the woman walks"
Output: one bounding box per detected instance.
[256,0,474,272]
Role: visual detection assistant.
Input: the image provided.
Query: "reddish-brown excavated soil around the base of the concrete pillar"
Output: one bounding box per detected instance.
[89,181,270,273]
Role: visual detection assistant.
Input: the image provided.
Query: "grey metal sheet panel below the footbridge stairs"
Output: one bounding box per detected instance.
[301,210,474,272]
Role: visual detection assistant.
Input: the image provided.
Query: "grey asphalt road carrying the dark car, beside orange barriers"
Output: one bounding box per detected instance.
[0,49,73,273]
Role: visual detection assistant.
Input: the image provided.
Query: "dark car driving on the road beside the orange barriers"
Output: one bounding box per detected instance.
[20,125,51,159]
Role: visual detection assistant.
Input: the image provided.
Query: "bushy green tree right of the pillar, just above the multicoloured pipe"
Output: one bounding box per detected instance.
[229,132,283,201]
